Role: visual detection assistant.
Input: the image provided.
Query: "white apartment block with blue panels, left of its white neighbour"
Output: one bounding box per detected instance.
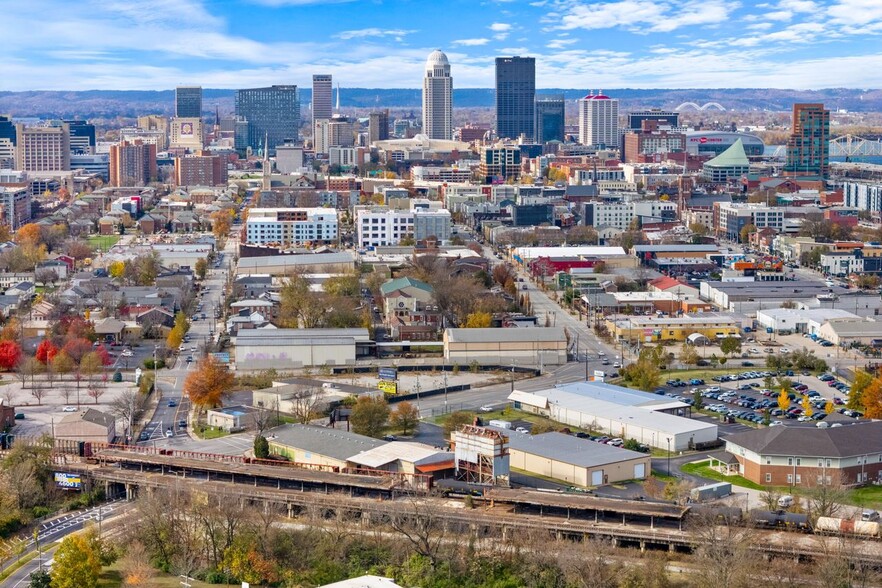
[245,208,338,246]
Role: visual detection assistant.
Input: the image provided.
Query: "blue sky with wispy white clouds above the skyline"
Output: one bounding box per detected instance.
[0,0,882,90]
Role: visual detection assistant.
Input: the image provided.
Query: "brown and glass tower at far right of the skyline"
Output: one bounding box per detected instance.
[784,104,830,178]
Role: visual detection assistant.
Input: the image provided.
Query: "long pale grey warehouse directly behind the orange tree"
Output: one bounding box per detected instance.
[235,328,373,371]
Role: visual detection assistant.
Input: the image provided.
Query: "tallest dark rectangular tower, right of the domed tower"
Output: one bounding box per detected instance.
[496,57,536,139]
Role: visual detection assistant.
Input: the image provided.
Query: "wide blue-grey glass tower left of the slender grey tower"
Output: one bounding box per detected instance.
[236,86,300,155]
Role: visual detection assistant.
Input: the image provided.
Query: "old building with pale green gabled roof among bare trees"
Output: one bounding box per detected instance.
[380,277,442,341]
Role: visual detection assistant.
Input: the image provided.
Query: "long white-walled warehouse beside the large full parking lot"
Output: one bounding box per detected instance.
[508,388,717,451]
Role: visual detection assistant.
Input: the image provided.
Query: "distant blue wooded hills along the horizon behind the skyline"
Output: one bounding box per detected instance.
[0,88,882,119]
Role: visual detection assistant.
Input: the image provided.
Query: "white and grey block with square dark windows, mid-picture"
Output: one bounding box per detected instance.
[356,207,452,247]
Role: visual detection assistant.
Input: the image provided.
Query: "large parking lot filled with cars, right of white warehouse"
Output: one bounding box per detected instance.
[655,370,862,426]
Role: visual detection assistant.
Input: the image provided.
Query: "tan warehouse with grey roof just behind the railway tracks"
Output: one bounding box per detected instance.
[500,429,652,486]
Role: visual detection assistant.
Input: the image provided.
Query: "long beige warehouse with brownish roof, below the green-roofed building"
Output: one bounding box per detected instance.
[444,327,567,367]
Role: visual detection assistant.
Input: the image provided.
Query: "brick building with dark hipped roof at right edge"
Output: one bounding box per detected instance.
[726,422,882,487]
